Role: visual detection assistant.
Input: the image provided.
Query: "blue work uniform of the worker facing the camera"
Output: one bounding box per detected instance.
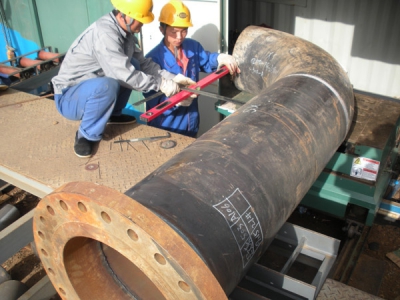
[145,38,219,137]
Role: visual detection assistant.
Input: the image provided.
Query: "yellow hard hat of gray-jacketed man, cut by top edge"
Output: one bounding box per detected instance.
[111,0,154,24]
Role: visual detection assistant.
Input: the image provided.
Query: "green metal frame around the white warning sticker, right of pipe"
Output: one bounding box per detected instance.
[301,118,400,226]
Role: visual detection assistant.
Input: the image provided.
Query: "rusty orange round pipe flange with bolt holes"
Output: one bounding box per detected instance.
[33,182,226,300]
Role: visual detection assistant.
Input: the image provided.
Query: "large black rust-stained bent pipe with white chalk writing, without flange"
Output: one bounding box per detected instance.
[125,26,354,294]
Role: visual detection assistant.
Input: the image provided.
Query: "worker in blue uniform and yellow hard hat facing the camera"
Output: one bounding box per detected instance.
[146,0,240,137]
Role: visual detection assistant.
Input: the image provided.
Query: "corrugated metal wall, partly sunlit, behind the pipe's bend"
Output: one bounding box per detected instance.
[230,0,400,98]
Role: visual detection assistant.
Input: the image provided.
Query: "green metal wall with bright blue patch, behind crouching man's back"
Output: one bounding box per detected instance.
[0,0,112,61]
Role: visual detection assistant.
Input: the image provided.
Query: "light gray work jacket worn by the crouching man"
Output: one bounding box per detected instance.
[52,13,169,94]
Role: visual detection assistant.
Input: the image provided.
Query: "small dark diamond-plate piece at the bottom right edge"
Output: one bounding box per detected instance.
[317,279,383,300]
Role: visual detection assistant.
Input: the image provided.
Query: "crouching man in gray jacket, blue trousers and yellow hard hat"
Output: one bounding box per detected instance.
[52,0,192,157]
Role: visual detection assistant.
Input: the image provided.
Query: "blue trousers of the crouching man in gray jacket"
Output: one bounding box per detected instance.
[54,77,132,141]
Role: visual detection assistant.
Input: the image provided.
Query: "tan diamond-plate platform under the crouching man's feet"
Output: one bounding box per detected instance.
[0,89,195,192]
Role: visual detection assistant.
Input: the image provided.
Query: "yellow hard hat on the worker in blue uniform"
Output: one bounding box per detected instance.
[158,0,193,27]
